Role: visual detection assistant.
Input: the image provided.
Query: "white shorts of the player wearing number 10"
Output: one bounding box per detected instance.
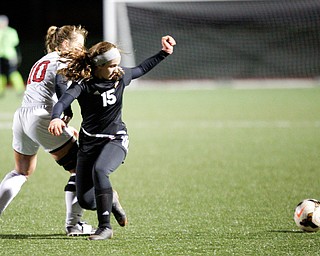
[12,106,73,155]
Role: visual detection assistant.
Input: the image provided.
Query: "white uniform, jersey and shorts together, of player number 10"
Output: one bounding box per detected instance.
[12,52,73,155]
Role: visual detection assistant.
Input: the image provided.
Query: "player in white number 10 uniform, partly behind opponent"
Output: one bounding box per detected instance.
[0,25,125,236]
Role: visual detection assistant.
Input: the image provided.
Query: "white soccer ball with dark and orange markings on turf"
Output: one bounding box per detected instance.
[294,199,320,232]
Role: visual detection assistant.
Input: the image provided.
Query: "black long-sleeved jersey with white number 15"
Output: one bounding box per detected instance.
[52,51,168,137]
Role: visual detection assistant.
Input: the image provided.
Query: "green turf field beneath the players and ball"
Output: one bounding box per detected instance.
[0,85,320,256]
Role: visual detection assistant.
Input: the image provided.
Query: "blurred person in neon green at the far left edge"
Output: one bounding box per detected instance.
[0,15,25,96]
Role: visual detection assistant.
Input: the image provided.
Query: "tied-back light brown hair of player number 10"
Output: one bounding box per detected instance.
[45,25,88,53]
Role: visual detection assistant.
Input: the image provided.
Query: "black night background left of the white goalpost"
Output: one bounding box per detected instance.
[0,0,103,80]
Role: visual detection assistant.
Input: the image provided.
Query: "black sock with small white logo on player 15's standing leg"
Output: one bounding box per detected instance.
[95,188,113,229]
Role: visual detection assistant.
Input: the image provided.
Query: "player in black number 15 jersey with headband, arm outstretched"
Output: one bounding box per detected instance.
[48,36,176,240]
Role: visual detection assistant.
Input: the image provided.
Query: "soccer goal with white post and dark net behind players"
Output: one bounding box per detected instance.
[104,0,320,80]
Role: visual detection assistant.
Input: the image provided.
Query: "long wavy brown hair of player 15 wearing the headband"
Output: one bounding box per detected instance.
[58,42,117,81]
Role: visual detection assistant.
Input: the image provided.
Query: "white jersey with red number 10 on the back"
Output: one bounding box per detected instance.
[22,52,66,109]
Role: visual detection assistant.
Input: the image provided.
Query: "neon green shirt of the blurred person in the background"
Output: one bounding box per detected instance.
[0,27,19,60]
